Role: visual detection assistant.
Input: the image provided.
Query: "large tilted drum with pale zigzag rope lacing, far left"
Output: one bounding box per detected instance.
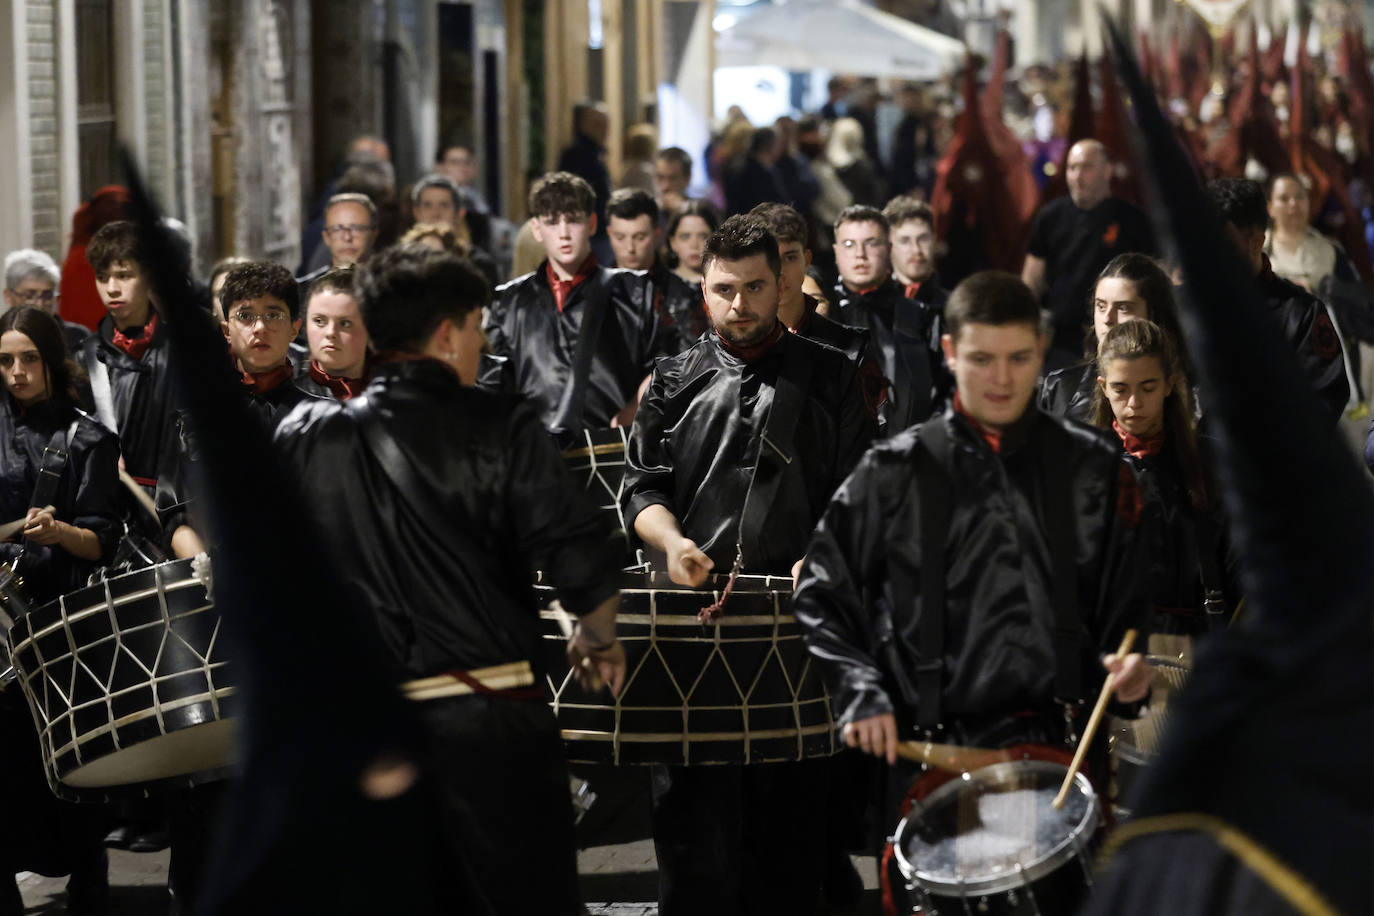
[10,559,234,798]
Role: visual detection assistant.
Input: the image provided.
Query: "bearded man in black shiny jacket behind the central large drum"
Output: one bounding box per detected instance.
[622,216,875,916]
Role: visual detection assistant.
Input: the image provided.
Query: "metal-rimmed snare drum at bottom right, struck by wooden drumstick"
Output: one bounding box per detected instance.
[893,759,1101,916]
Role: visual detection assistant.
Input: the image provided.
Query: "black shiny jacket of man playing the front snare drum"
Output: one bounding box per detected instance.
[793,409,1145,736]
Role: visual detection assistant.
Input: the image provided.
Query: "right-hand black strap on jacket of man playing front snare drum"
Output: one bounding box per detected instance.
[1040,422,1083,700]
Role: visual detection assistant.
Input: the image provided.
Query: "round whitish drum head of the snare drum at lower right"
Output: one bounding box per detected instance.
[893,761,1098,895]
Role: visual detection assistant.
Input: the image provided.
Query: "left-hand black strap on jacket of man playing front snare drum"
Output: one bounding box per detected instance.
[893,419,954,731]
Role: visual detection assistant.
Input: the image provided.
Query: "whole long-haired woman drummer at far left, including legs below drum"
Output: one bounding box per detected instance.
[0,306,121,916]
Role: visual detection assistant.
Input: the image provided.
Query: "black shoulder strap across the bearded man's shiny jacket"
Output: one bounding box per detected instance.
[739,332,815,560]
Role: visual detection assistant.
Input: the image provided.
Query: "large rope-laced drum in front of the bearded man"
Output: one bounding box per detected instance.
[543,573,838,764]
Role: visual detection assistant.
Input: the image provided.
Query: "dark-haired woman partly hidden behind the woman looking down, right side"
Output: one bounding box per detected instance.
[1040,253,1191,422]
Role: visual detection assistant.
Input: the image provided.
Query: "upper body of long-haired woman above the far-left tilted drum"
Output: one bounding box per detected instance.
[0,306,120,603]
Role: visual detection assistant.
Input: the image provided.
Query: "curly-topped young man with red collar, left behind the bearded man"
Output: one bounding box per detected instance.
[482,172,682,435]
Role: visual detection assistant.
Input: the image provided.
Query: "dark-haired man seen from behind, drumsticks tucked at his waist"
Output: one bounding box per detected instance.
[275,246,625,916]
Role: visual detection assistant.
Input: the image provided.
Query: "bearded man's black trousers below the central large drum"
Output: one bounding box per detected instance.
[653,759,829,916]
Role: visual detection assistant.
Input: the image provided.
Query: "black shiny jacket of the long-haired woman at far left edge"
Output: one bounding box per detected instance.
[0,394,122,603]
